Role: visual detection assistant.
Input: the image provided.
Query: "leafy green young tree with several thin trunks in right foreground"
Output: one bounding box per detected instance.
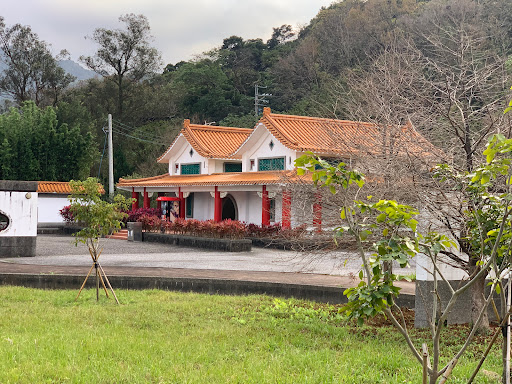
[296,143,512,384]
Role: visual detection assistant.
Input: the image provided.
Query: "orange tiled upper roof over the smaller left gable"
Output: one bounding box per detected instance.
[157,119,253,161]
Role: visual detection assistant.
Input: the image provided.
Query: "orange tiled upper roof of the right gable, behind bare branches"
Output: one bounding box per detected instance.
[260,107,442,157]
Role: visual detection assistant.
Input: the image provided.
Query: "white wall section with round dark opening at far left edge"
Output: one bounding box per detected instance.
[0,191,38,236]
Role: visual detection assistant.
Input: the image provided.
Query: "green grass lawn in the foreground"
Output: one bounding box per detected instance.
[0,287,500,383]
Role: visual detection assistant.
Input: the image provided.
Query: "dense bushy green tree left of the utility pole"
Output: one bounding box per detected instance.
[0,101,96,181]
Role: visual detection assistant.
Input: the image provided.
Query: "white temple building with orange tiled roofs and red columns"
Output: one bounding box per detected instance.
[117,108,436,228]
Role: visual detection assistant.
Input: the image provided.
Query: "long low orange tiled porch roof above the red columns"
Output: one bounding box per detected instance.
[117,171,311,188]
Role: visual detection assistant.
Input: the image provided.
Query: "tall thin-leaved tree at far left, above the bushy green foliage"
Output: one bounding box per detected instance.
[0,17,75,105]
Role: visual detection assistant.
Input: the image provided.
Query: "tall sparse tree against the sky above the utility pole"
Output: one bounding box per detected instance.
[80,13,161,119]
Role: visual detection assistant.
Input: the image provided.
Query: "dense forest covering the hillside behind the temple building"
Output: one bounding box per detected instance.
[0,0,512,180]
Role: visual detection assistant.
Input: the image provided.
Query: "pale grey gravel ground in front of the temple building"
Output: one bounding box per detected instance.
[2,235,415,276]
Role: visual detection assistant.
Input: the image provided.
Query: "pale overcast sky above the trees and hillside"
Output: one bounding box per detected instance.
[0,0,333,65]
